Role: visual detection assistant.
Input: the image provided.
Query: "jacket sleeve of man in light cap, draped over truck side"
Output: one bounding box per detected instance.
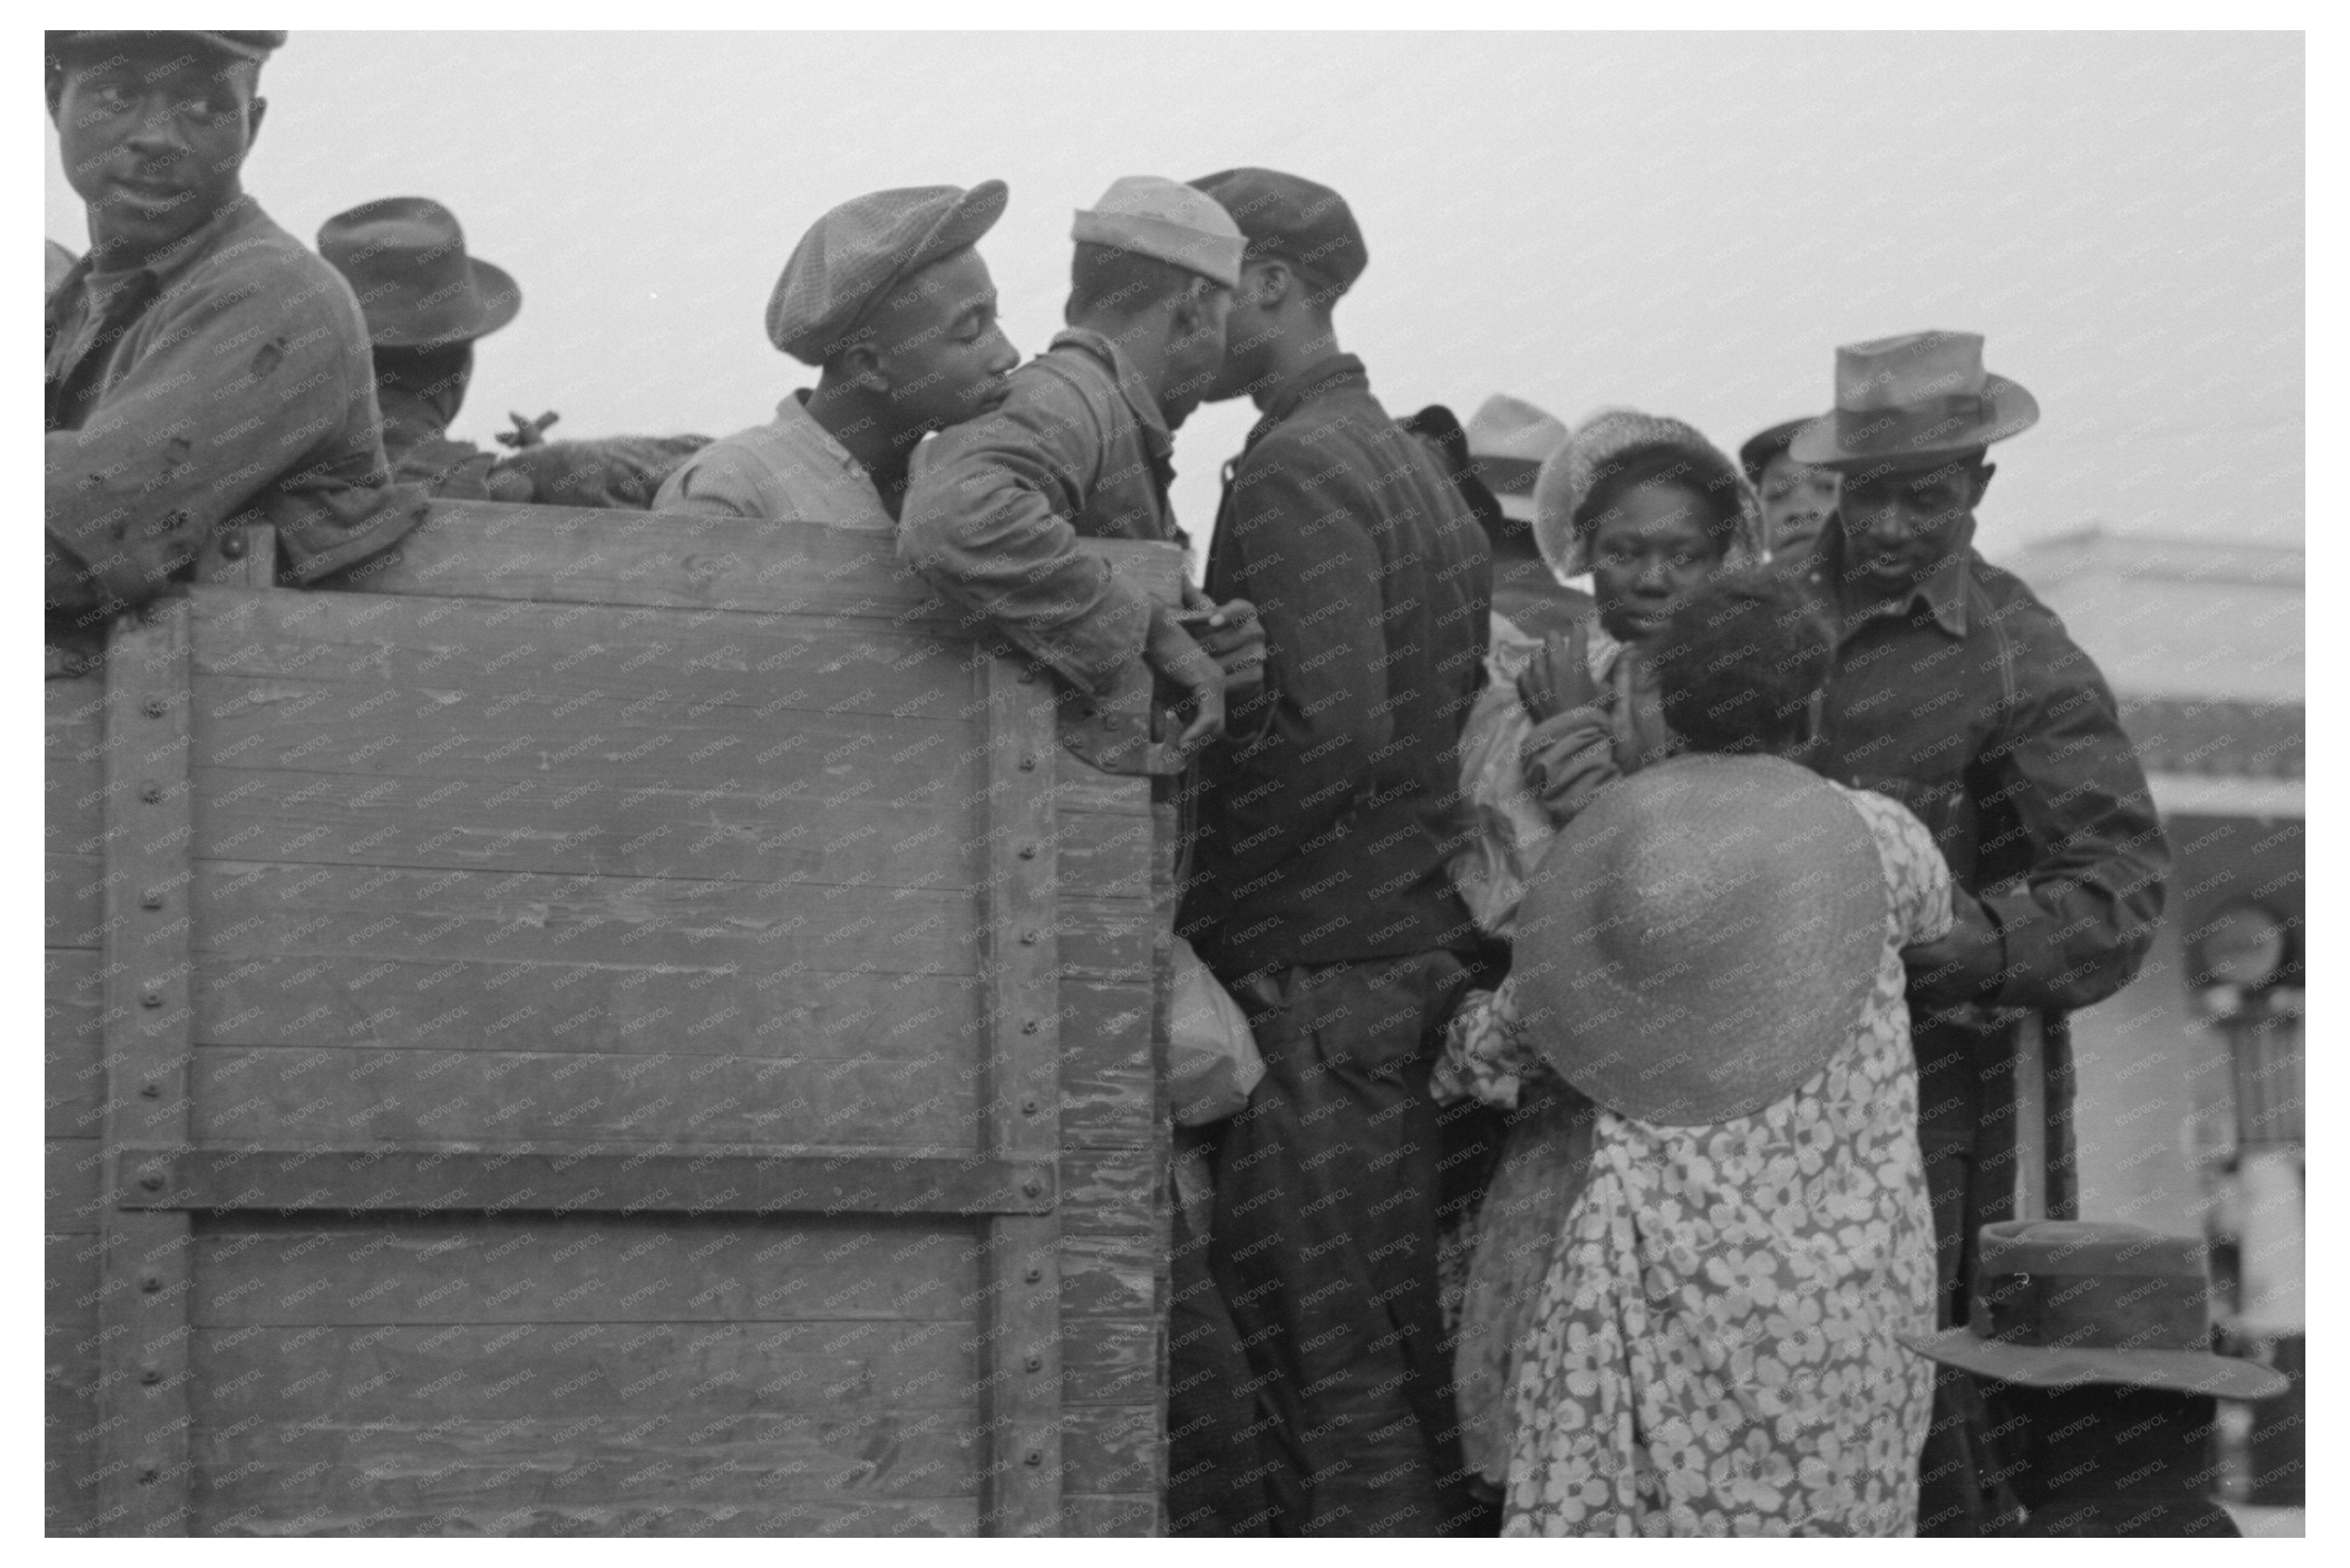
[898,371,1152,691]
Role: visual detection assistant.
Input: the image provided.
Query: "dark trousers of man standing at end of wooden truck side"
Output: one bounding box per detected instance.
[1210,952,1469,1535]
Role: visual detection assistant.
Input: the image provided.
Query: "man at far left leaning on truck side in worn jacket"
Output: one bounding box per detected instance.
[42,33,425,672]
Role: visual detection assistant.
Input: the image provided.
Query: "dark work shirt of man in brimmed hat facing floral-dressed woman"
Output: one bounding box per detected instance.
[1805,519,2169,1011]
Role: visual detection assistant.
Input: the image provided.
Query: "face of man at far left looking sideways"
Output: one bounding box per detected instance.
[49,33,263,265]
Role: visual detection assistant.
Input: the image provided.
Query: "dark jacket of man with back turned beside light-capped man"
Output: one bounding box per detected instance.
[1180,355,1492,978]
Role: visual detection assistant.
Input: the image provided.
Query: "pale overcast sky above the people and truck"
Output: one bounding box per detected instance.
[47,31,2303,555]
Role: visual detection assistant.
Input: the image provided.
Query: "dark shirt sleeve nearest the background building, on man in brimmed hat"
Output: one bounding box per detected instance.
[1981,616,2169,1008]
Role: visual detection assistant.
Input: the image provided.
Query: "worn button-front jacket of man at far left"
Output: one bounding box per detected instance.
[45,197,425,595]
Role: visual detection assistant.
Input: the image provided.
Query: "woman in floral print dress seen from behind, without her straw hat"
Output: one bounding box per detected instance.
[1445,578,1951,1535]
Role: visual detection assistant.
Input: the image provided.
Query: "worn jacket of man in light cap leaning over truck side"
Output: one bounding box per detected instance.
[898,327,1184,691]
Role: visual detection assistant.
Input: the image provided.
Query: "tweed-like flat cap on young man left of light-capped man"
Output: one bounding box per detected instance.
[766,179,1011,364]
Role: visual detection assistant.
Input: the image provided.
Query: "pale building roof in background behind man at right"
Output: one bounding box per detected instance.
[1997,524,2305,710]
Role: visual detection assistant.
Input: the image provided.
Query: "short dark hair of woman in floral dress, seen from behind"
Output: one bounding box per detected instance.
[1652,566,1836,752]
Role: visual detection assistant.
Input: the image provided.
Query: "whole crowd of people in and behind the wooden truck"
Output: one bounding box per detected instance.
[45,33,2268,1535]
